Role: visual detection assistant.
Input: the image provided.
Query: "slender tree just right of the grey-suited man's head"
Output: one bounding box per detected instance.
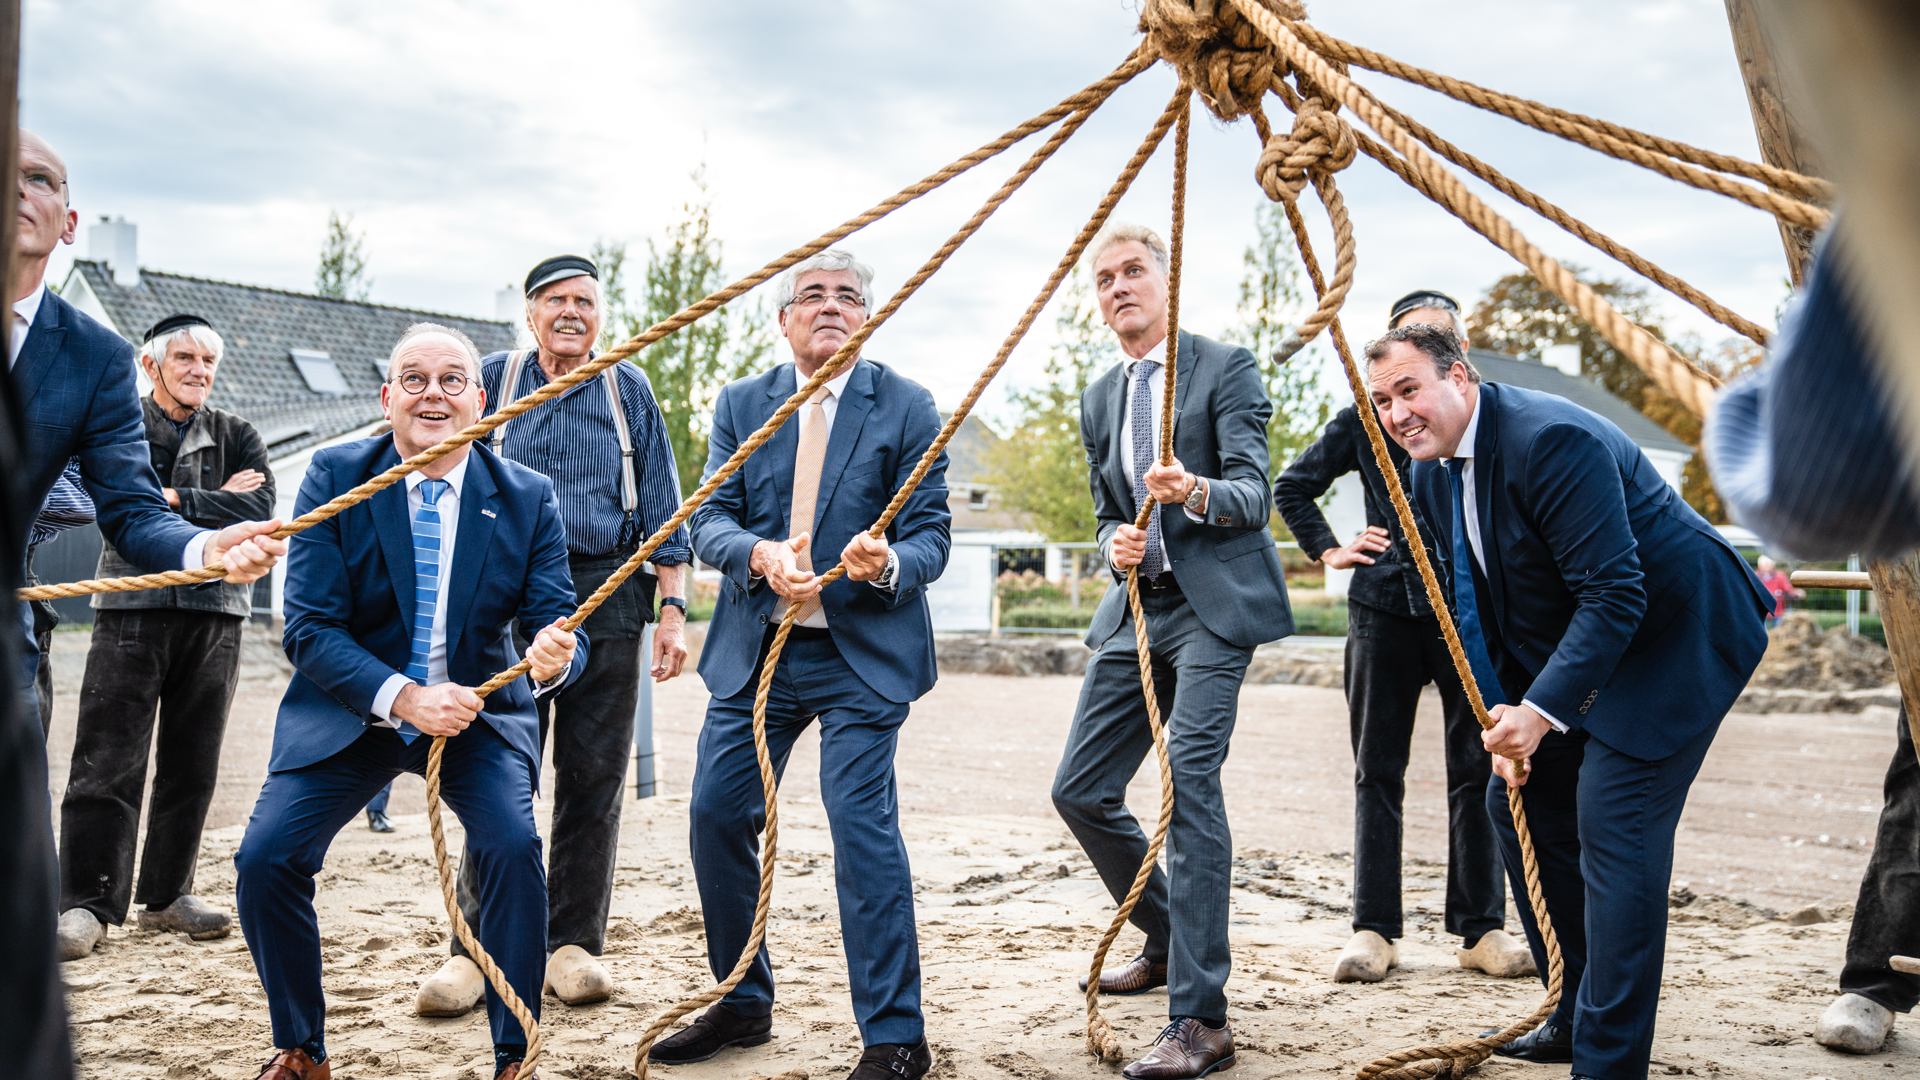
[1221,200,1332,495]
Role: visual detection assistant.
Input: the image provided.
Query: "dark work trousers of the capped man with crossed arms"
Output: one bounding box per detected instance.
[60,607,242,926]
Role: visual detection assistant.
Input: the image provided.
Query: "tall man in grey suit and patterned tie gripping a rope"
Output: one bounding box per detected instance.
[1054,223,1294,1080]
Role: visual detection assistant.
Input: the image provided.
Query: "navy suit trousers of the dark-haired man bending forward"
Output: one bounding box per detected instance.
[1486,721,1720,1080]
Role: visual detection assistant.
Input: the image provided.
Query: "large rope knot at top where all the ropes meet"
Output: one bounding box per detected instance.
[1140,0,1306,123]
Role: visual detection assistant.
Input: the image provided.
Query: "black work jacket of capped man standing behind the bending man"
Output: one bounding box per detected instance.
[1273,405,1432,617]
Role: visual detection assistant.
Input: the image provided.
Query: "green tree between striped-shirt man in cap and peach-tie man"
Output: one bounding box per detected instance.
[591,165,774,492]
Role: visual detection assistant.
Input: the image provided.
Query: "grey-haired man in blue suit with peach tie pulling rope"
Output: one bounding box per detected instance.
[651,250,950,1080]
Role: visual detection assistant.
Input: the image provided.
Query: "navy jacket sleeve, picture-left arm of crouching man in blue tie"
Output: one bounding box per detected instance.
[280,461,401,717]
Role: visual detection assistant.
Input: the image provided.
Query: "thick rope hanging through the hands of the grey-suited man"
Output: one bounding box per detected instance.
[1087,83,1194,1061]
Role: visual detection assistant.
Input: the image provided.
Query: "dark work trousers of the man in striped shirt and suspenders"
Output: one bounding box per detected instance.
[453,553,653,957]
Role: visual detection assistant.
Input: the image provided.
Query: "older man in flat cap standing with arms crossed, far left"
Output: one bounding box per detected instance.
[60,315,275,961]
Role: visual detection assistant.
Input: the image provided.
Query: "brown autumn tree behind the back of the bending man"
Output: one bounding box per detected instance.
[1467,265,1763,525]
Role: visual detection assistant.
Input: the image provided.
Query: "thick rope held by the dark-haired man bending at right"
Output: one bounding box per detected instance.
[1286,161,1565,1080]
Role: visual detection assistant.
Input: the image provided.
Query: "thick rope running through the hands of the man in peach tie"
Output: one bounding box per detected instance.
[634,82,1175,1080]
